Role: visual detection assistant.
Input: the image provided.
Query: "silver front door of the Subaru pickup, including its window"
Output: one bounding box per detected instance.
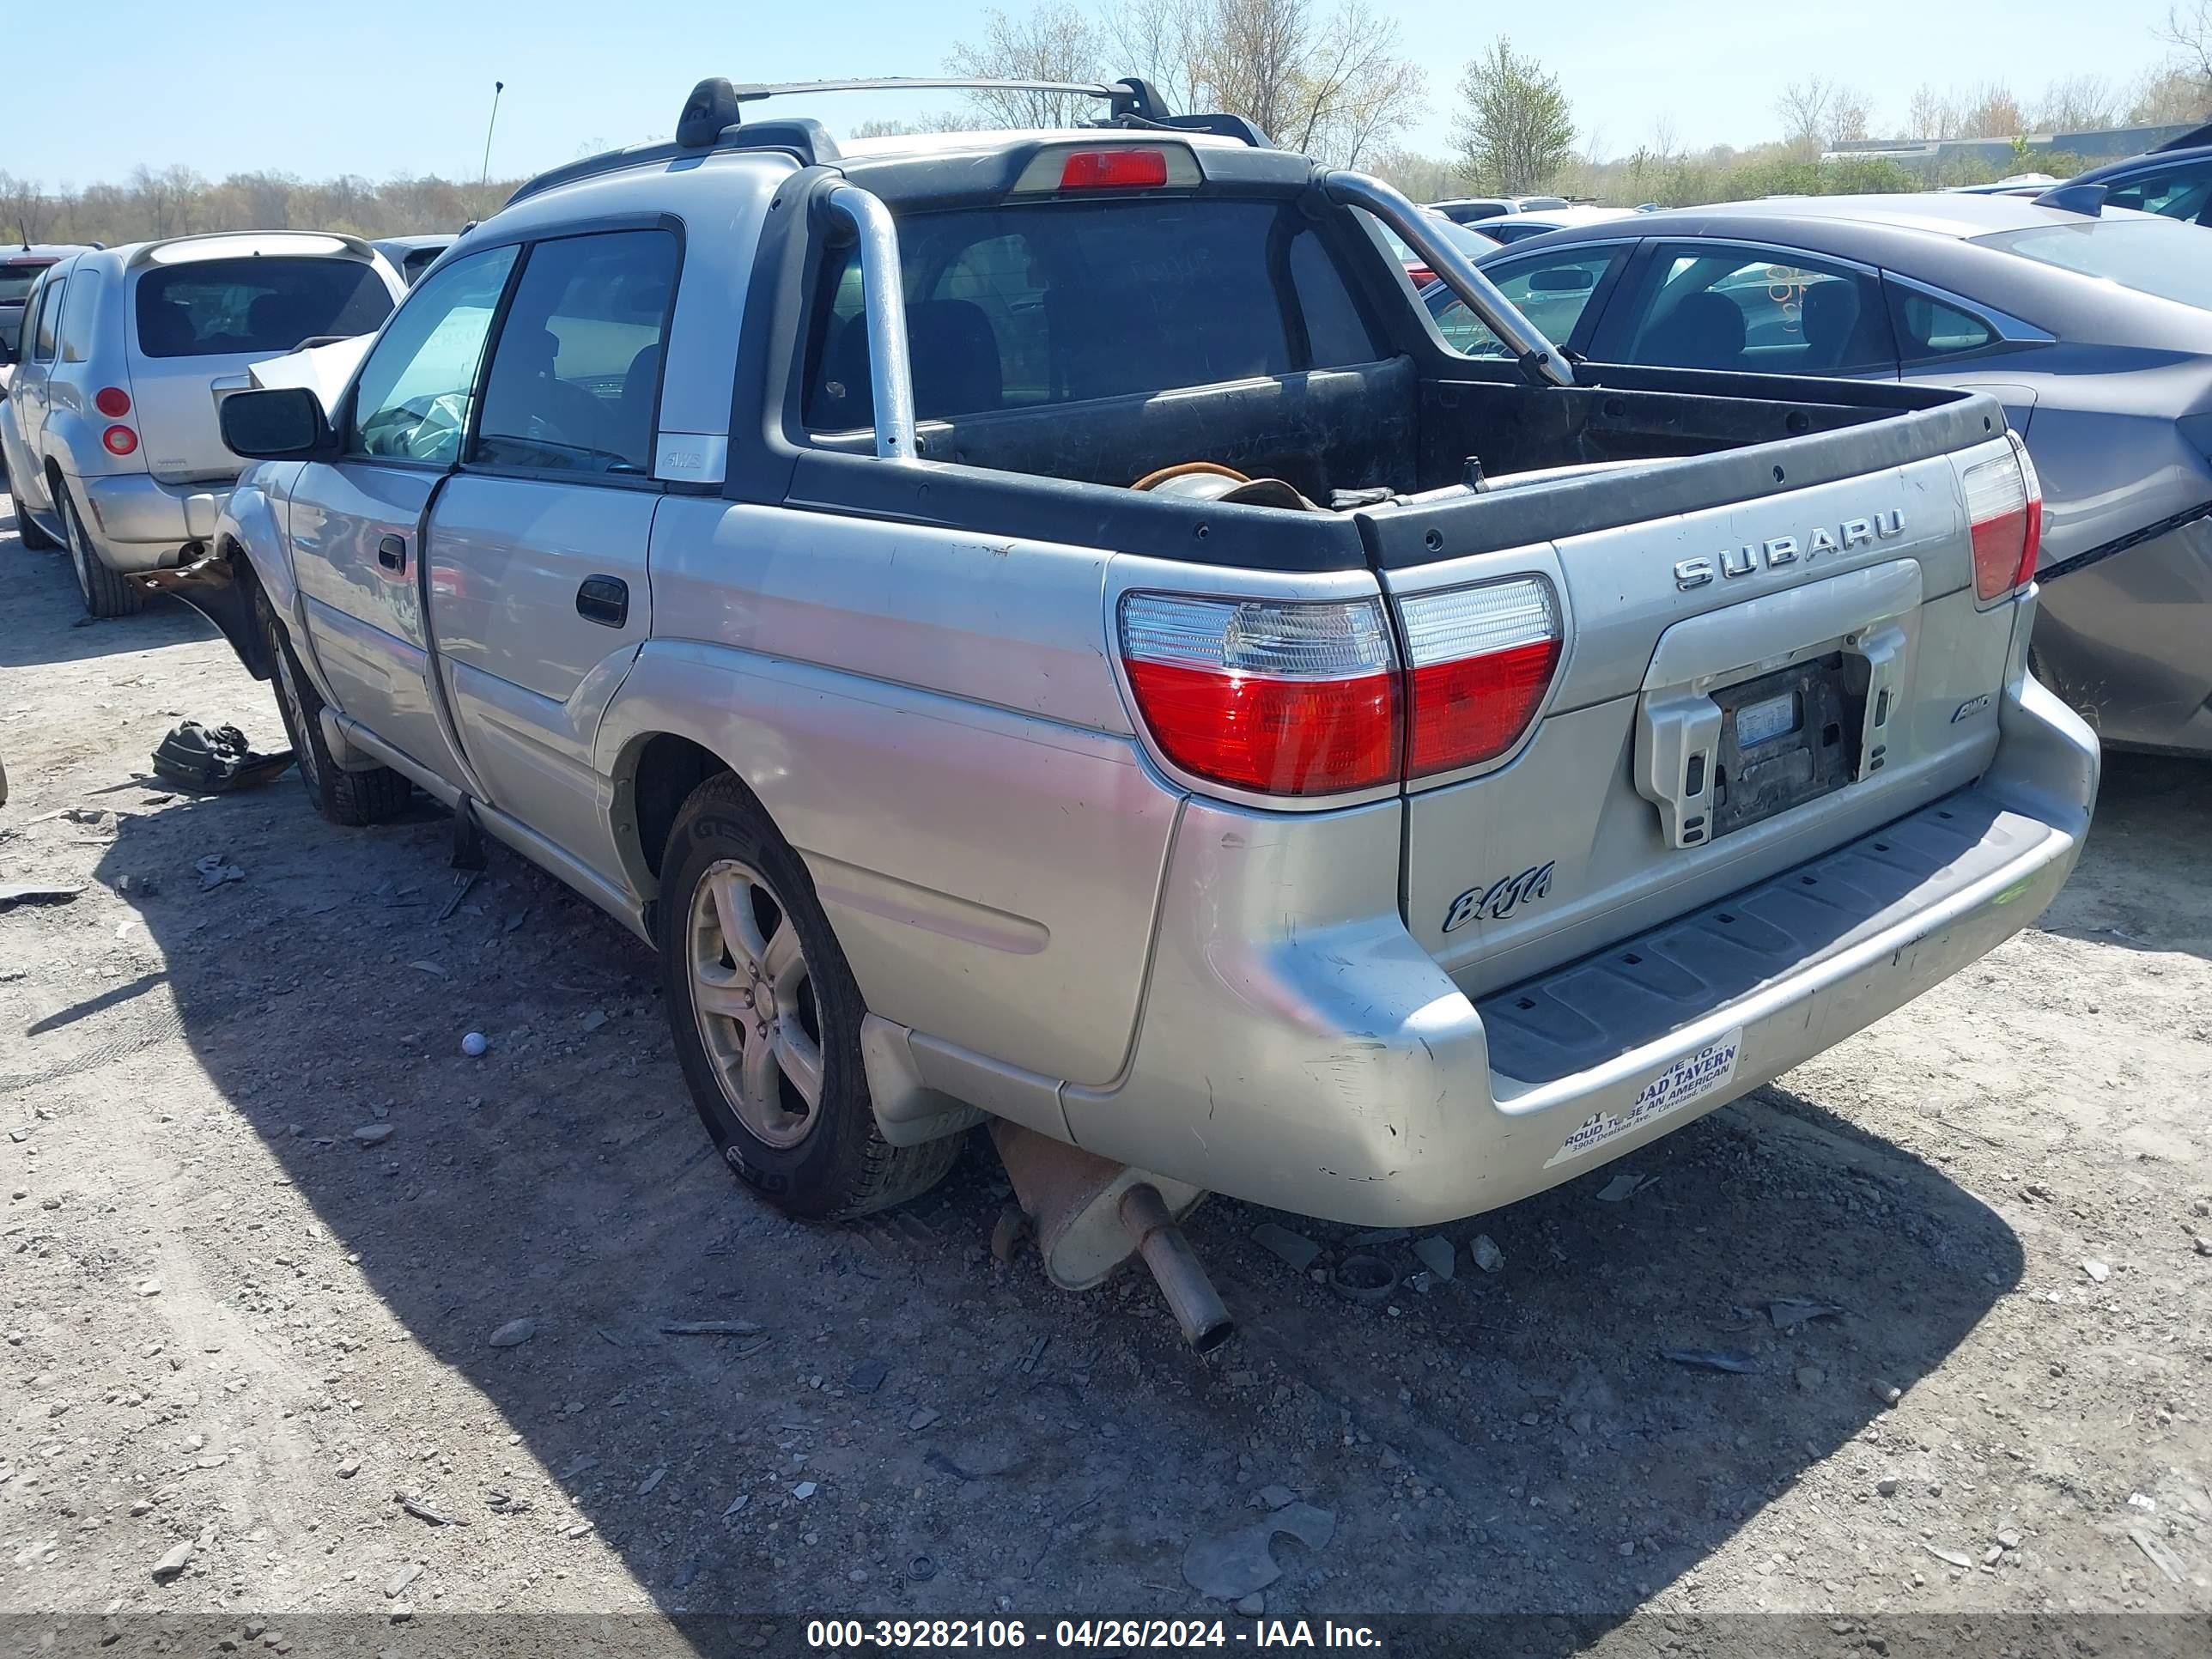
[292,248,515,783]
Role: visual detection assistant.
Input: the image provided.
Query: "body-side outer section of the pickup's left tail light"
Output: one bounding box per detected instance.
[1121,592,1398,794]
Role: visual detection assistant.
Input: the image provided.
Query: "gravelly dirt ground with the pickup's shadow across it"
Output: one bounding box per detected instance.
[0,506,2212,1652]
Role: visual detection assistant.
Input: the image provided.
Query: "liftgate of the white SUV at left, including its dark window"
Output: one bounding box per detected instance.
[124,239,392,484]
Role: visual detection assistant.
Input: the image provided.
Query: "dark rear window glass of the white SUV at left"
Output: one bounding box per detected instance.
[137,257,392,356]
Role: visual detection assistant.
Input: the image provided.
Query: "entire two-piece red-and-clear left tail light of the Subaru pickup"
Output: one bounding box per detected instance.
[1121,577,1562,796]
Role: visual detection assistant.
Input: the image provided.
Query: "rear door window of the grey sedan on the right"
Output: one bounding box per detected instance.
[1628,246,1898,374]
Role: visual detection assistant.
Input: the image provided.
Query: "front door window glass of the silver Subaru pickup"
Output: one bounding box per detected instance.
[345,248,515,467]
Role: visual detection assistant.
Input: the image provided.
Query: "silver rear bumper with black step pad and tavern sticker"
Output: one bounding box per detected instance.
[1061,679,2097,1225]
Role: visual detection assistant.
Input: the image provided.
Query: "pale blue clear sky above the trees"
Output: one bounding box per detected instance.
[0,0,2170,188]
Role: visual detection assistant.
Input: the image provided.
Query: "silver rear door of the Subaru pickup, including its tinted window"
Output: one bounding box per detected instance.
[427,228,681,872]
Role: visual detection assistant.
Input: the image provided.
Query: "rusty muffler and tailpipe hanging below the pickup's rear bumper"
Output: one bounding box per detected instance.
[991,1117,1237,1354]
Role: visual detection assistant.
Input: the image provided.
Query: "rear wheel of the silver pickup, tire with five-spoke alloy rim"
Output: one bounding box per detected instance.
[657,772,964,1221]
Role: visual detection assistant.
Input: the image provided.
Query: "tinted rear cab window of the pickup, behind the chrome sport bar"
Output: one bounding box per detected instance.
[805,199,1378,429]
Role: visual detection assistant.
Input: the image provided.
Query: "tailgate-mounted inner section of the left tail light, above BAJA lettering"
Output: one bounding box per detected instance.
[1398,575,1562,779]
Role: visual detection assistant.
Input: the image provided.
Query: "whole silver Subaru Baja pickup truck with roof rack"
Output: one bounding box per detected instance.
[167,82,2097,1343]
